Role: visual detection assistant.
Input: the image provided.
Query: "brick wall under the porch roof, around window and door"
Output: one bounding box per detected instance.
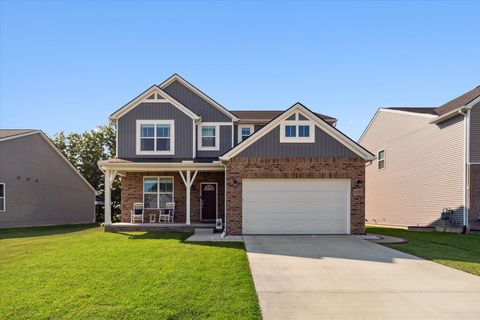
[120,172,225,223]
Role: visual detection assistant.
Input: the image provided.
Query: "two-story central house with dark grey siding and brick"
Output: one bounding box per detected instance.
[99,75,374,235]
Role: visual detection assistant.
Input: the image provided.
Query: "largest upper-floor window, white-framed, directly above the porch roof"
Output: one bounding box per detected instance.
[137,120,175,155]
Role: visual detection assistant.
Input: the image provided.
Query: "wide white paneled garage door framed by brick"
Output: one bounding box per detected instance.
[242,179,350,234]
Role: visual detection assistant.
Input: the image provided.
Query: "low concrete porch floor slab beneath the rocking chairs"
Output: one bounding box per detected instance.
[105,222,215,233]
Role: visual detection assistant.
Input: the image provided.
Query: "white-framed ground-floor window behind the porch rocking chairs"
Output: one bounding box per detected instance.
[143,177,173,209]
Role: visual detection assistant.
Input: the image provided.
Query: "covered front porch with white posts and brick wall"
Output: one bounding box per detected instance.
[99,159,225,232]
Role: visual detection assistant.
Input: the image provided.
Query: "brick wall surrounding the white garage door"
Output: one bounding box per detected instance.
[227,157,365,235]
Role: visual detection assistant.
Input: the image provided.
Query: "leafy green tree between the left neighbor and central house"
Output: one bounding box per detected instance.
[51,124,120,221]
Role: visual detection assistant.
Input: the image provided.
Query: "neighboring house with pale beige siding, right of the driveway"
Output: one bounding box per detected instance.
[359,86,480,229]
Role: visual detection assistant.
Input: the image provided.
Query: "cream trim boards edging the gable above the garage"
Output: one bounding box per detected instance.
[220,102,375,161]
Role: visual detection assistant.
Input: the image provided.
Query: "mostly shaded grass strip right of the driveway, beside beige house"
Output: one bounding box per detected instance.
[367,226,480,276]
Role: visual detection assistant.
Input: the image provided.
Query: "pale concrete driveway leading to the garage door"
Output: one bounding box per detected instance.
[244,236,480,320]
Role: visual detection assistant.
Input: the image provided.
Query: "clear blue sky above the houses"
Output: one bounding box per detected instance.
[0,1,480,139]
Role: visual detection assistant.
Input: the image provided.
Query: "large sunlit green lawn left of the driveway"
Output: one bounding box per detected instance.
[0,226,261,320]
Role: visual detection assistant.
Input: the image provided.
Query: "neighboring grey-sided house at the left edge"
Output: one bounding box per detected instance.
[0,129,95,228]
